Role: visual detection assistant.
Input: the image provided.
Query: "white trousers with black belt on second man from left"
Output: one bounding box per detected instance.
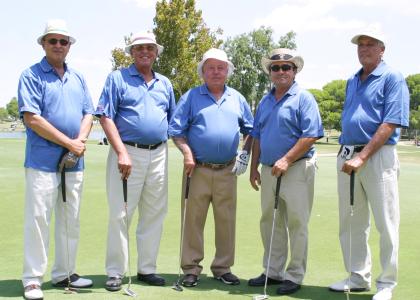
[106,143,168,277]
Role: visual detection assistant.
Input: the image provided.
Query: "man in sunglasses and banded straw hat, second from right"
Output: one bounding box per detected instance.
[248,48,324,295]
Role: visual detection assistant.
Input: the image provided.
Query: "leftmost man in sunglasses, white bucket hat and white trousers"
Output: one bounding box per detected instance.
[18,20,93,299]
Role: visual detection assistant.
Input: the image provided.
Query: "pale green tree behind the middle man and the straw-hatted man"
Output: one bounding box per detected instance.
[223,26,296,110]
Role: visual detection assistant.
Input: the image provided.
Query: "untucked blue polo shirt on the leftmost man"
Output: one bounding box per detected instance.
[18,57,93,172]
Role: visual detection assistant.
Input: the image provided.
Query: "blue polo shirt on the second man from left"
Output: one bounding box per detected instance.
[95,64,175,145]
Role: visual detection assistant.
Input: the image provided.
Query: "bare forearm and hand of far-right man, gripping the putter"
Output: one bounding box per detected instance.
[341,123,397,175]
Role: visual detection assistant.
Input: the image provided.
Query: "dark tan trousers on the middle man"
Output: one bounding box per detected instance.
[181,163,236,277]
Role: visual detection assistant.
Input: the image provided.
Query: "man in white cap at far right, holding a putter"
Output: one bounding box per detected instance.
[330,31,409,300]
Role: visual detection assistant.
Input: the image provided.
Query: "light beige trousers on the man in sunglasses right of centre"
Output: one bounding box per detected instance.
[260,158,316,284]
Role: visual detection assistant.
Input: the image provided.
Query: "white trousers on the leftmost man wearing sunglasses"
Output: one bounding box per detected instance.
[22,168,83,286]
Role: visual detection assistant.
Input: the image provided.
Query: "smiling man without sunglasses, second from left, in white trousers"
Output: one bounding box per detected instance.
[95,32,175,291]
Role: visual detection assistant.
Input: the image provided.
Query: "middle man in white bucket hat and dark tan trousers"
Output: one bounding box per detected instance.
[169,48,253,287]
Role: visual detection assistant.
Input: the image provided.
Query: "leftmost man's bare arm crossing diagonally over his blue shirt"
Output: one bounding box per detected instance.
[23,112,86,156]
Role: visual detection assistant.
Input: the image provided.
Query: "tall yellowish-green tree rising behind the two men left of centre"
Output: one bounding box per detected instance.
[154,0,222,98]
